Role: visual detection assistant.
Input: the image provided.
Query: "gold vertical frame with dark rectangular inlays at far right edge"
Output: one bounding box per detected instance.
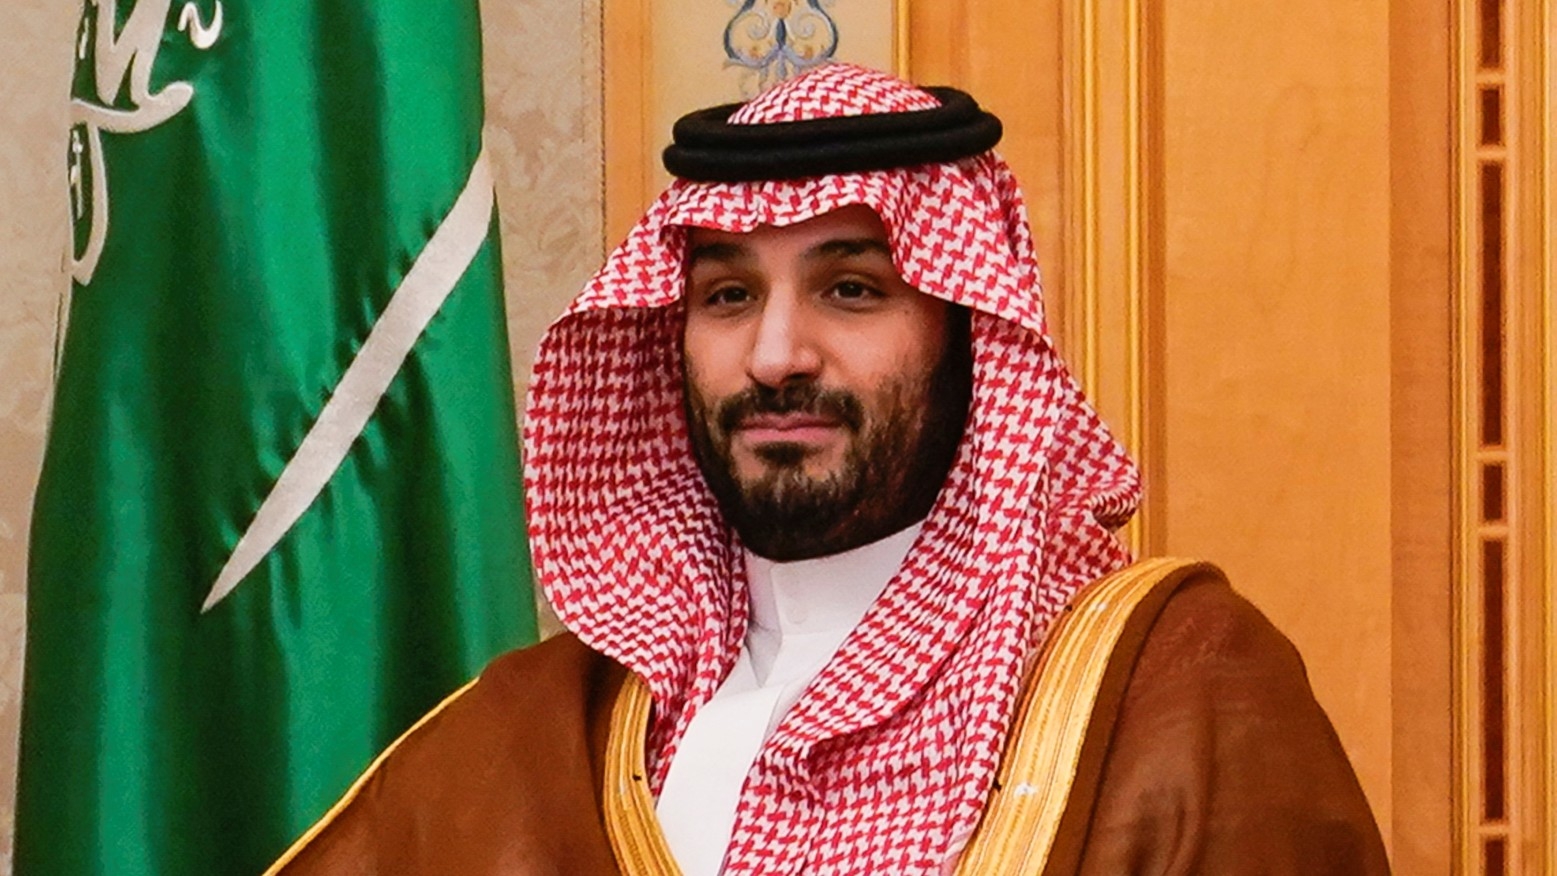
[1454,0,1557,876]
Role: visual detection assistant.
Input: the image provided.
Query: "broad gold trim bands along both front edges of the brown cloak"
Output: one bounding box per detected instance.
[603,559,1224,876]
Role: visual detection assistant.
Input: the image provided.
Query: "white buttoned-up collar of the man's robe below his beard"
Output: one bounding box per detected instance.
[746,521,923,636]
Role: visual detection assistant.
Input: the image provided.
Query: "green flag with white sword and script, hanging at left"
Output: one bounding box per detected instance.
[16,0,536,876]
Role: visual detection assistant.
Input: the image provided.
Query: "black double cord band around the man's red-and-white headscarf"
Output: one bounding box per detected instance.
[665,87,1001,182]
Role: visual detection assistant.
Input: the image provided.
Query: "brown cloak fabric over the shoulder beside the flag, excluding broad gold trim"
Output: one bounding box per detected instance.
[269,633,626,876]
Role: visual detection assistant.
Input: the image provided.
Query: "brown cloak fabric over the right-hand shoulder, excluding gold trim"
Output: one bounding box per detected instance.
[1081,573,1387,874]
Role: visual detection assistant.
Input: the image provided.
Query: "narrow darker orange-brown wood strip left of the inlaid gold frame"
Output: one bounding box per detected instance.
[1389,0,1454,873]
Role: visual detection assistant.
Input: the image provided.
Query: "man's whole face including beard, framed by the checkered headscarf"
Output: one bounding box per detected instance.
[682,205,972,560]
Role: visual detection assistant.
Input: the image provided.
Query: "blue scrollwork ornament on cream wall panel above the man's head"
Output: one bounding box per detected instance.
[724,0,838,93]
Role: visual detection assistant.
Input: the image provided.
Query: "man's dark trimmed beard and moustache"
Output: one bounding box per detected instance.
[685,308,973,562]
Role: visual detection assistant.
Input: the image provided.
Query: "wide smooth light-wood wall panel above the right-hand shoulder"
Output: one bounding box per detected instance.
[1157,0,1392,839]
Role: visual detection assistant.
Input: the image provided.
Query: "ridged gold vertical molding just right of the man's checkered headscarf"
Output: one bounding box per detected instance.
[1060,0,1166,555]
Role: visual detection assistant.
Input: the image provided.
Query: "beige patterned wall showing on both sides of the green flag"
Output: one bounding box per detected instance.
[0,0,603,876]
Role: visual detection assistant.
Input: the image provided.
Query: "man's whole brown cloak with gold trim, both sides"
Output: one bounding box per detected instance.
[271,560,1389,876]
